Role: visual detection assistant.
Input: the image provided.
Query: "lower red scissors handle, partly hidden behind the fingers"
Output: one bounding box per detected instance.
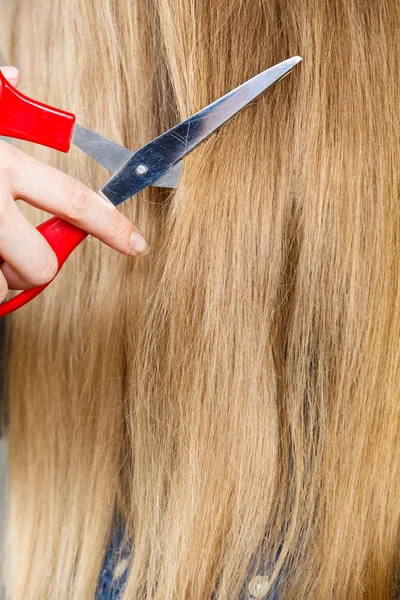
[0,217,88,317]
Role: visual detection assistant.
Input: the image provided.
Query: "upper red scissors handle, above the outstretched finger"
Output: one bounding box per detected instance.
[0,71,75,152]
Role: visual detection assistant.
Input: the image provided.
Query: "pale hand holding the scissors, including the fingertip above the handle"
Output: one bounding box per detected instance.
[0,67,149,302]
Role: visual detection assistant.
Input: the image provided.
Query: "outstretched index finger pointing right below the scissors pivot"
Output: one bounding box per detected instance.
[6,141,149,255]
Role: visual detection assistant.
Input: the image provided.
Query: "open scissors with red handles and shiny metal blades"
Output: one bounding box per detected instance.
[0,56,302,317]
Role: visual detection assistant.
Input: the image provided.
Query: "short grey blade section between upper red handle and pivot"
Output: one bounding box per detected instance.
[71,123,134,173]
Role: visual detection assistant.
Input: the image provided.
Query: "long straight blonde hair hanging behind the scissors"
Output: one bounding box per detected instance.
[2,0,400,600]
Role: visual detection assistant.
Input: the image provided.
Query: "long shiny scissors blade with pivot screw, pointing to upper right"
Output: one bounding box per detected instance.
[100,56,301,206]
